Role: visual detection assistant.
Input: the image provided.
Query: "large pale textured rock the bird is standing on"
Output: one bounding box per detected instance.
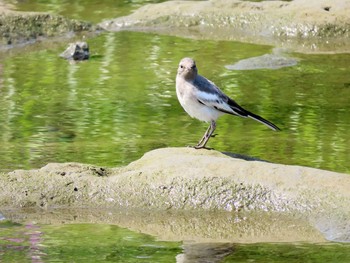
[0,148,350,241]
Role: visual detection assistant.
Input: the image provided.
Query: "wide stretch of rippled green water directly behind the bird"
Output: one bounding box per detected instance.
[0,29,350,172]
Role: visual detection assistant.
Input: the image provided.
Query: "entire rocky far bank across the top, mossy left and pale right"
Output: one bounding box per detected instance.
[0,0,350,53]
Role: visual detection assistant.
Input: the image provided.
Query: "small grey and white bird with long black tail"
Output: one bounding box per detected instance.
[176,57,280,149]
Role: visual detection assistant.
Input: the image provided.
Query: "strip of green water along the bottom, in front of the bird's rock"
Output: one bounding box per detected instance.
[0,221,350,263]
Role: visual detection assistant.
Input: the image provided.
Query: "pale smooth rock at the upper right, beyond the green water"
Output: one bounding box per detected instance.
[100,0,350,52]
